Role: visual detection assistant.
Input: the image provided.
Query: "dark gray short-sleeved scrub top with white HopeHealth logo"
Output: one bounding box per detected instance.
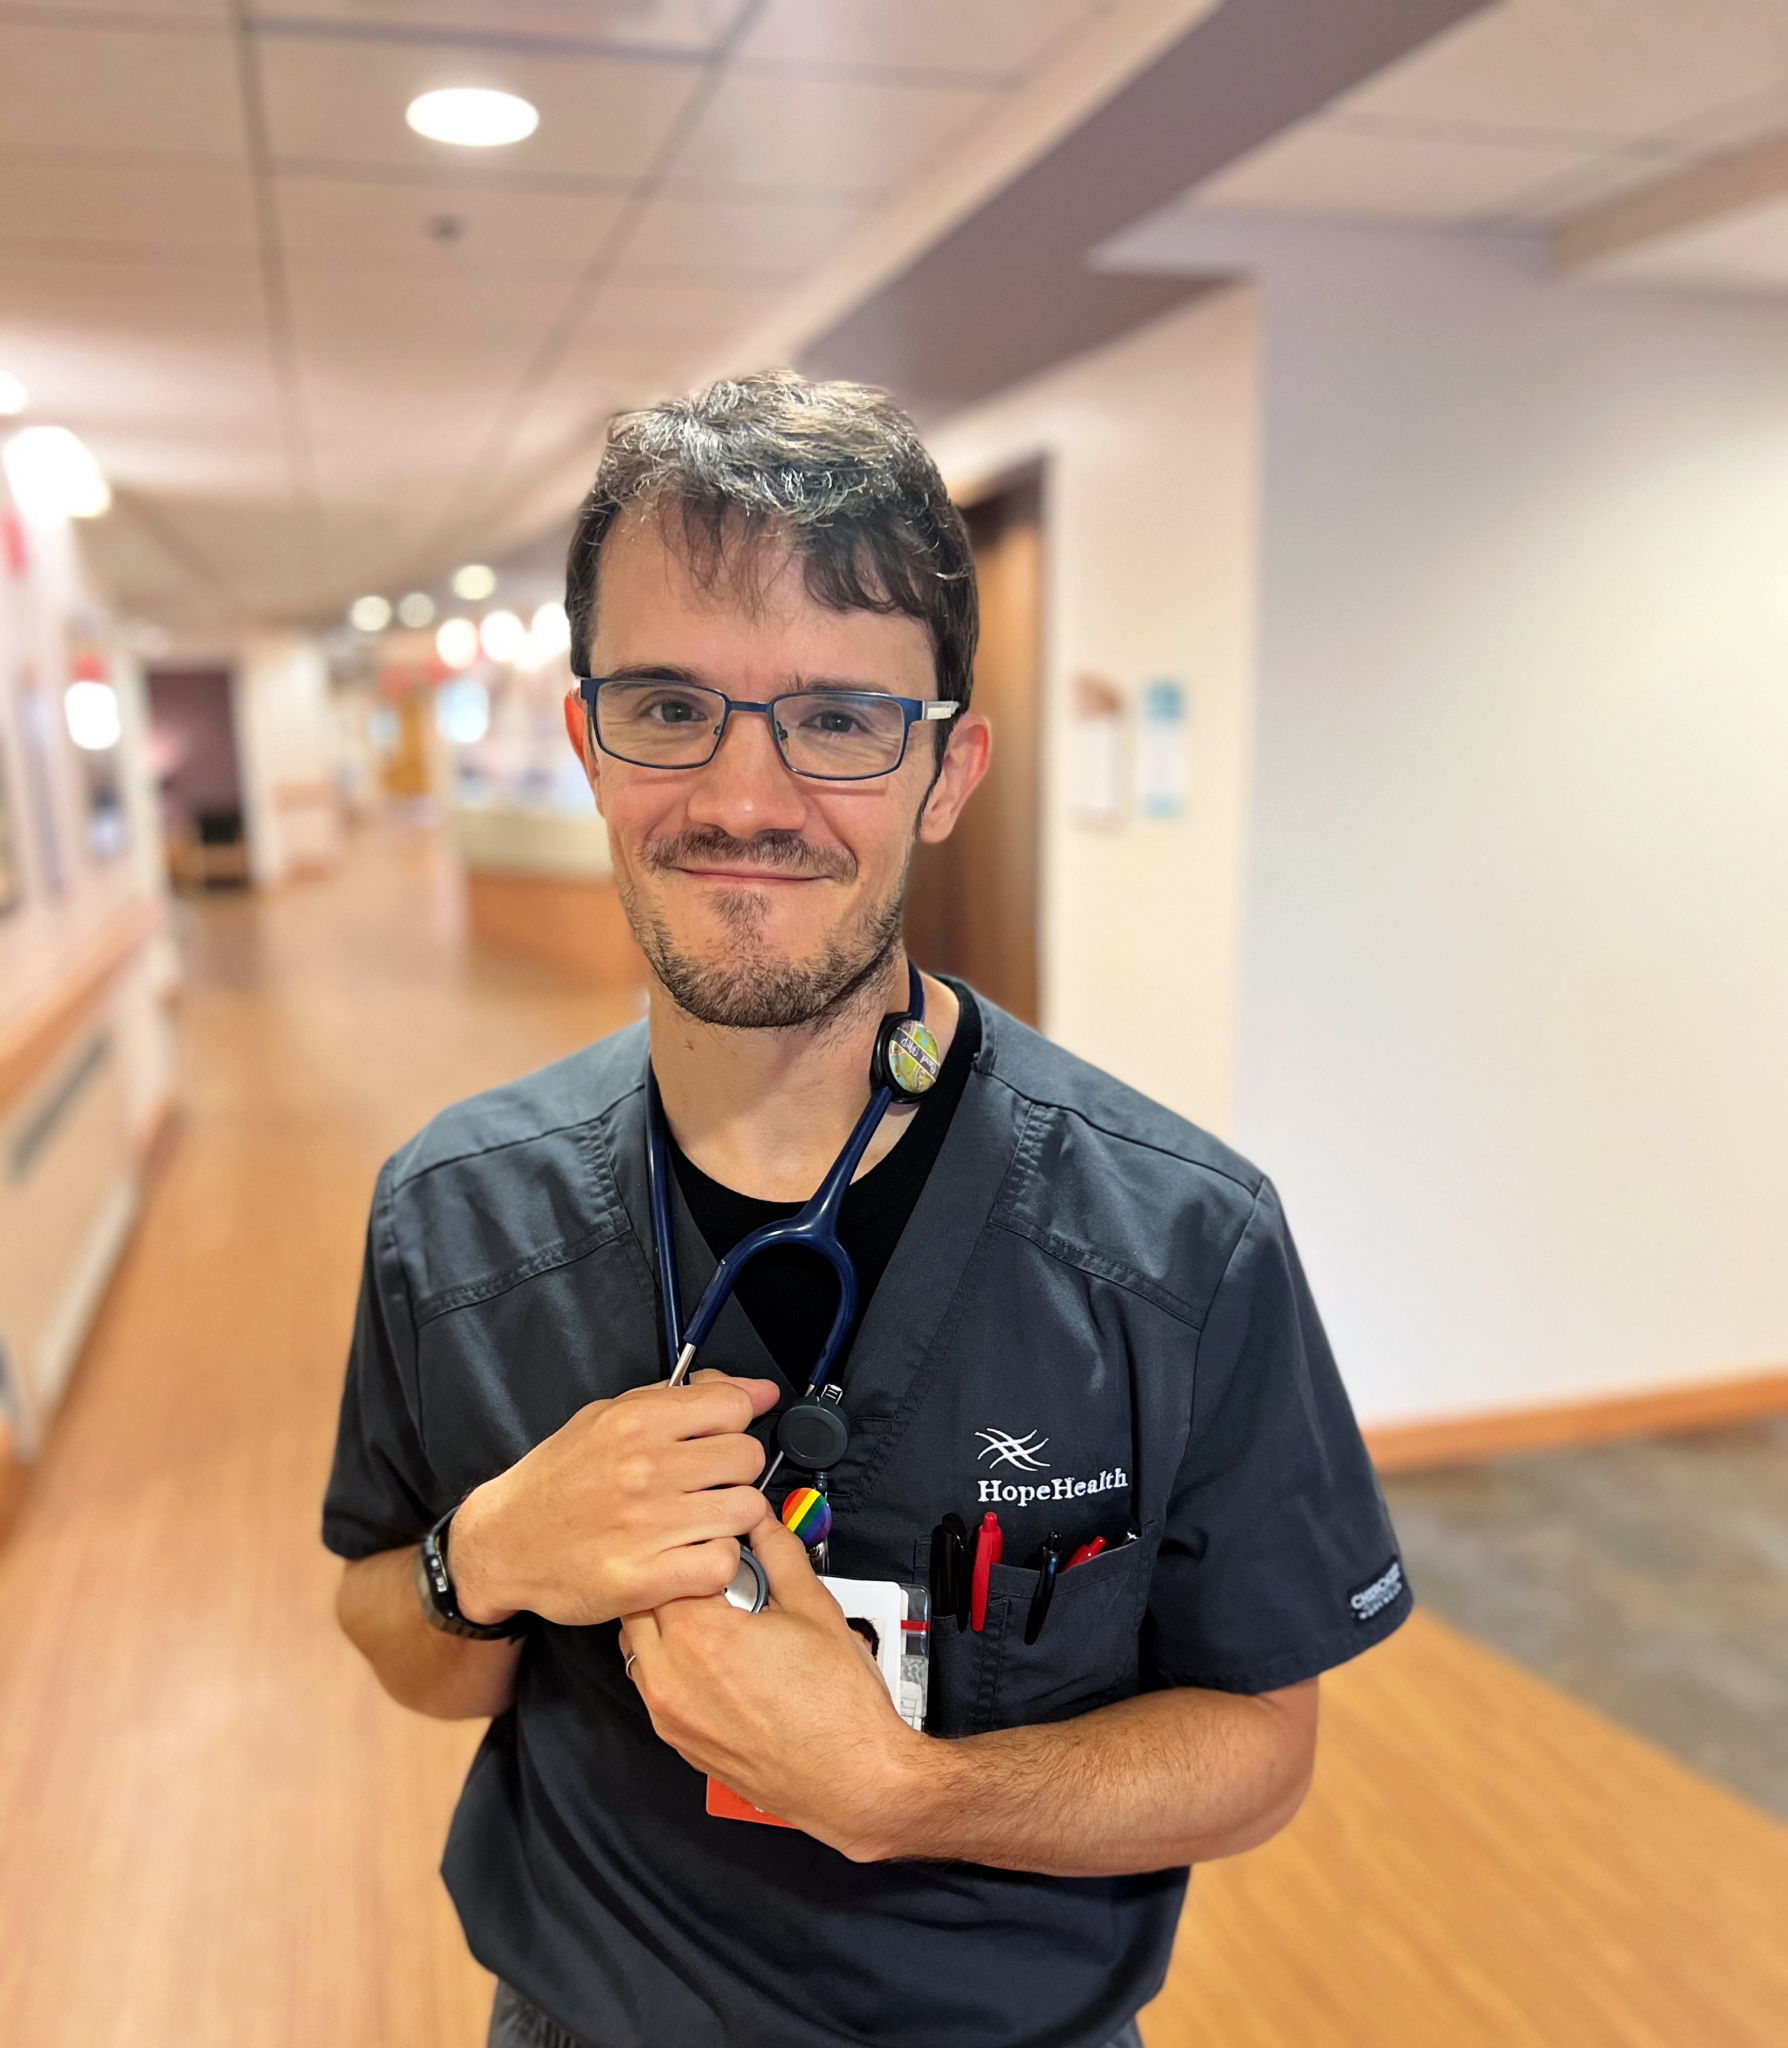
[324,997,1409,2048]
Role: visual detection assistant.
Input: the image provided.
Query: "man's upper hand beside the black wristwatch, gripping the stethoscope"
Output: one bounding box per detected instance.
[446,1372,776,1626]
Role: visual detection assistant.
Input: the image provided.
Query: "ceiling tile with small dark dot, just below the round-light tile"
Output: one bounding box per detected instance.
[279,176,621,276]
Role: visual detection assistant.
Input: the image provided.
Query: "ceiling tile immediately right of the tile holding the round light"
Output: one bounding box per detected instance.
[676,74,995,197]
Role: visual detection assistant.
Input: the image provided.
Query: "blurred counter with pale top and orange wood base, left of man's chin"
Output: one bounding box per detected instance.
[453,803,645,989]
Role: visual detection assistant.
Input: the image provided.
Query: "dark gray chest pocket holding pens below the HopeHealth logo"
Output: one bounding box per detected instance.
[926,1540,1153,1735]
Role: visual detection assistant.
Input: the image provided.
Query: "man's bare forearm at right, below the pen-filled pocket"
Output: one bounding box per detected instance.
[875,1679,1317,1878]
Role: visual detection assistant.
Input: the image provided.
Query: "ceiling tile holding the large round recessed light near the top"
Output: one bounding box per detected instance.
[258,37,700,178]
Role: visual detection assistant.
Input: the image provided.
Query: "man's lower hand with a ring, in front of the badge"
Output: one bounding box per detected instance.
[621,1520,928,1862]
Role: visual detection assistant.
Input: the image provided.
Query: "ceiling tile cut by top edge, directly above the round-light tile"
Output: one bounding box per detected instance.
[250,0,746,53]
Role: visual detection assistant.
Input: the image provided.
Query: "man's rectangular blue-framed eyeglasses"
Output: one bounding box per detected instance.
[578,676,961,782]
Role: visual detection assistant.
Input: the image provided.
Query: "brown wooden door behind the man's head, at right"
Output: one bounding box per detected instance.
[905,473,1042,1024]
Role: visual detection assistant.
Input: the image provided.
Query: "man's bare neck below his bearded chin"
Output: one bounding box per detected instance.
[649,948,959,1202]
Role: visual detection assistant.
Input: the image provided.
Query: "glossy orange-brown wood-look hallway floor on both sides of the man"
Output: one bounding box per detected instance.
[0,840,1788,2048]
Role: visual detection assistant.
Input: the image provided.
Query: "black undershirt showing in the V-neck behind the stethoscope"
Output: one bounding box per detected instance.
[670,981,981,1386]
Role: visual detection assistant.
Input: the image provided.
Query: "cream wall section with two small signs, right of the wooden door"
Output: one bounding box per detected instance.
[928,289,1258,1130]
